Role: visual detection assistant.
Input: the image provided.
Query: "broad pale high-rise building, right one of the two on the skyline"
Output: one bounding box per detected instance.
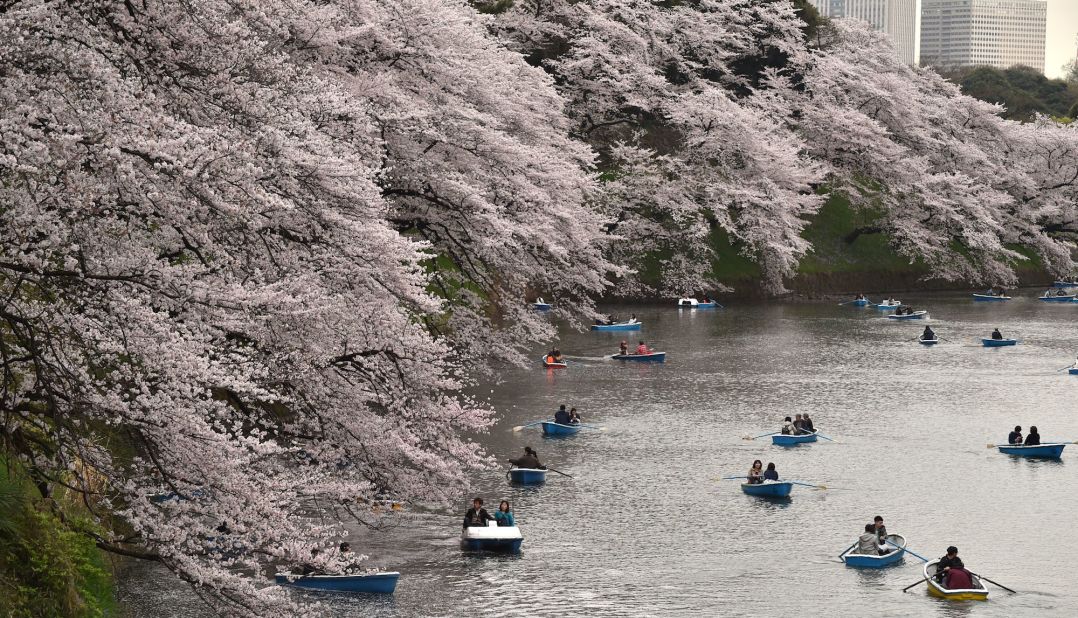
[921,0,1047,71]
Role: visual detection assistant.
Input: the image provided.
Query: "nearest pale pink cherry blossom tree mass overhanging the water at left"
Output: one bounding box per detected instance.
[0,0,617,616]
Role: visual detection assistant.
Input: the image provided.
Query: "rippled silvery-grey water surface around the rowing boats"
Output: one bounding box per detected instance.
[121,290,1078,617]
